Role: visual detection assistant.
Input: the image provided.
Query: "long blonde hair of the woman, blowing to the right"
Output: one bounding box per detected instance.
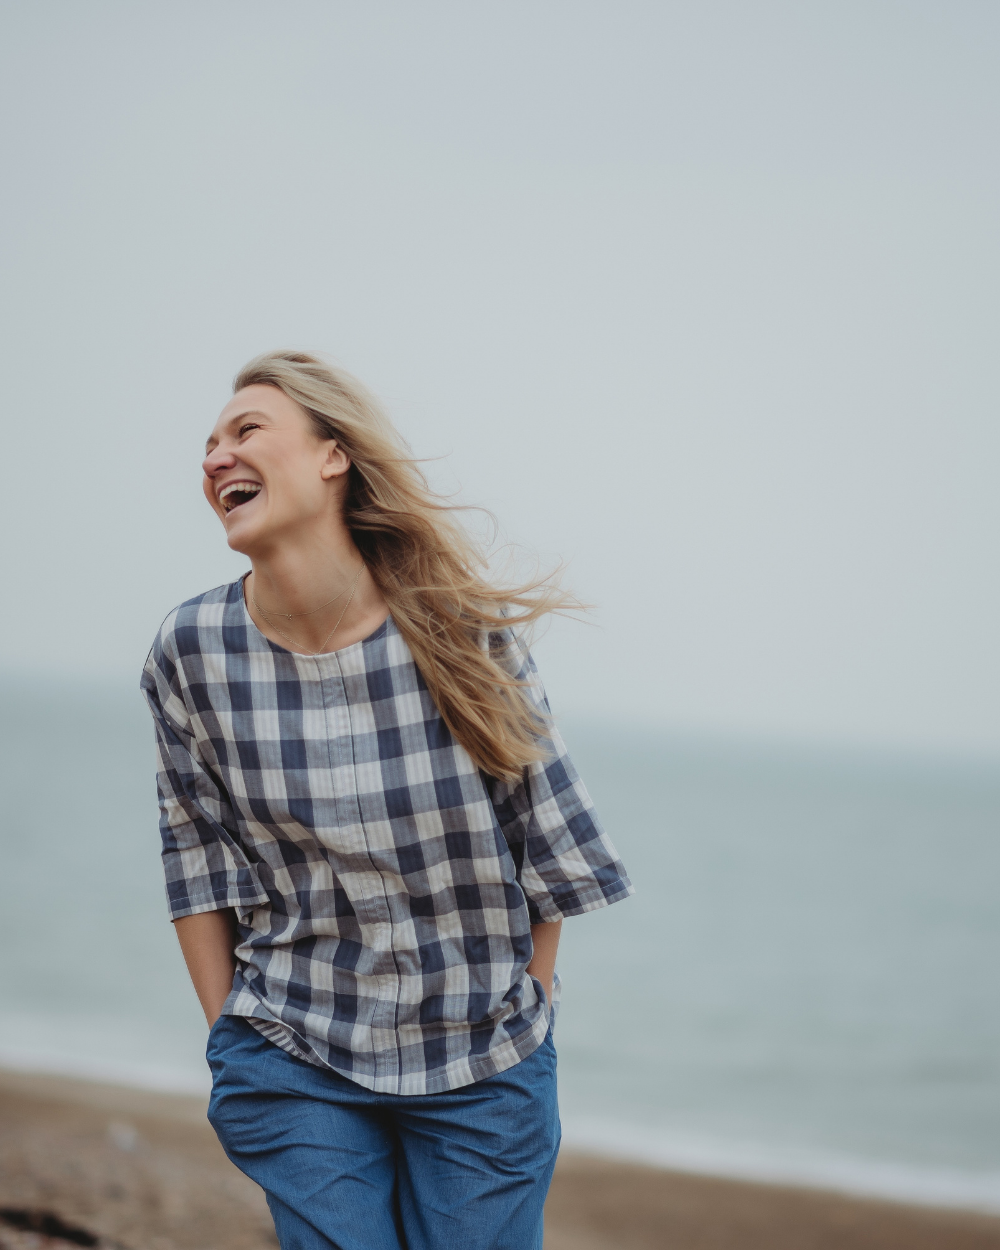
[233,351,579,780]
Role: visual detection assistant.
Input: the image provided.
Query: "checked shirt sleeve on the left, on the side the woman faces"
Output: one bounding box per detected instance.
[141,646,269,920]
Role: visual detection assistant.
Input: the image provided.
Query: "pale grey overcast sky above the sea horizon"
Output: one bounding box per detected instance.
[0,0,1000,756]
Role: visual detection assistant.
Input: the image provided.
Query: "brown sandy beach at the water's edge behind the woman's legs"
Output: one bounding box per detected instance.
[0,1073,1000,1250]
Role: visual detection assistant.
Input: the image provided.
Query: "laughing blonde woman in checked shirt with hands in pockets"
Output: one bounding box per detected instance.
[143,351,631,1250]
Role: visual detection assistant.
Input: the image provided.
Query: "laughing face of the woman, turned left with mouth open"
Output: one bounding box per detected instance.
[201,386,350,556]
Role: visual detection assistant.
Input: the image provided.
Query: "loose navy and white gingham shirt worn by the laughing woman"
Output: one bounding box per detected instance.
[143,581,633,1094]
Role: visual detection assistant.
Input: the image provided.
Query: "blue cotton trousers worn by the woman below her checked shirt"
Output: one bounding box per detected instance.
[208,1016,560,1250]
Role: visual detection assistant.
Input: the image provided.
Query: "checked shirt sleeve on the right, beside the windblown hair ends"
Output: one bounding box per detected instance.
[490,631,635,925]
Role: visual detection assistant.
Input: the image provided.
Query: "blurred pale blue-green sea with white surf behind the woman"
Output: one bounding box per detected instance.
[0,681,1000,1213]
